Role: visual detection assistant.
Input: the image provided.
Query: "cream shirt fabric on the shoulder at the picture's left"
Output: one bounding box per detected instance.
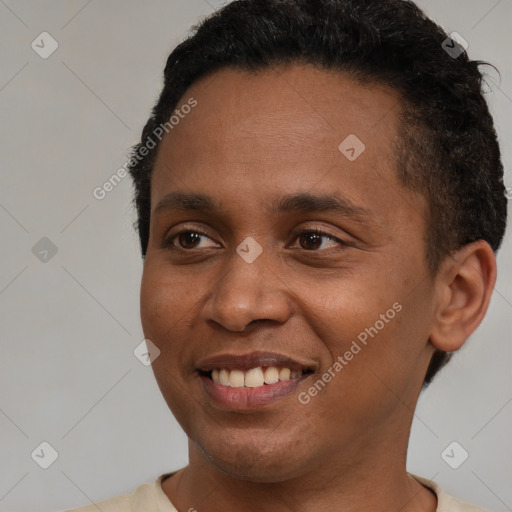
[65,473,177,512]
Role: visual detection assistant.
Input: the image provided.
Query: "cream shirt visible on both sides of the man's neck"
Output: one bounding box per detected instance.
[65,473,485,512]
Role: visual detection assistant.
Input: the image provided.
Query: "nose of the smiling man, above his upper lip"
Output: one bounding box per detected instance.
[202,244,291,332]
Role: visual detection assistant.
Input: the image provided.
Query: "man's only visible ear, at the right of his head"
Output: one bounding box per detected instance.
[430,240,496,352]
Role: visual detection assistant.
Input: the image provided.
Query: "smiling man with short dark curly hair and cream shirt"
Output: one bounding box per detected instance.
[65,0,506,512]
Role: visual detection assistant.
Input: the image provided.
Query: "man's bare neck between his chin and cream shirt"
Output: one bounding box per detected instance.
[162,430,437,512]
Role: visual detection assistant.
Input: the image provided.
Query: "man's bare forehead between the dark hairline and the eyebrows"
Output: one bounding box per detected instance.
[151,64,422,226]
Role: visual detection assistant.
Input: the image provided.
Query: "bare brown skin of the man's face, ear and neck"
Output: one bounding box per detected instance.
[141,64,496,512]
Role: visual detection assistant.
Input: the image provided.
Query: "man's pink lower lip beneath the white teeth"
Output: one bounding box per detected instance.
[201,375,308,411]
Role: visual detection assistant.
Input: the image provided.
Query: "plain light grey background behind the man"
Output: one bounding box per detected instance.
[0,0,512,511]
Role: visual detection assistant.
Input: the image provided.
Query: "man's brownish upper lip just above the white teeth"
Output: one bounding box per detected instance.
[197,352,317,372]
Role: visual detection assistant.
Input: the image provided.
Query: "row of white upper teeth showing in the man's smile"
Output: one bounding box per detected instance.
[212,366,302,388]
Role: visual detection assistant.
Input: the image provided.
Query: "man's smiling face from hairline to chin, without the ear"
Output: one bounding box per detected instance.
[141,65,435,482]
